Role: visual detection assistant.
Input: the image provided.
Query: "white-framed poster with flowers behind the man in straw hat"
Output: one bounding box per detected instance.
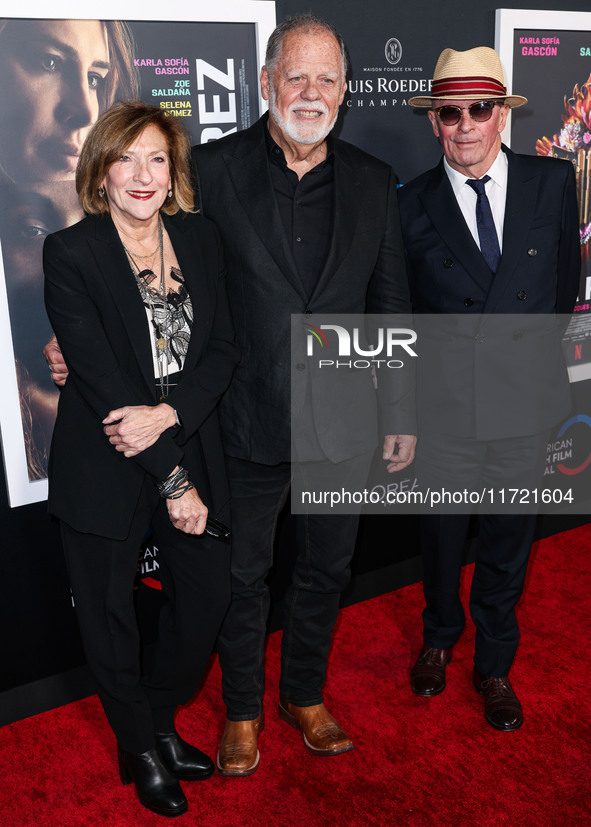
[496,9,591,382]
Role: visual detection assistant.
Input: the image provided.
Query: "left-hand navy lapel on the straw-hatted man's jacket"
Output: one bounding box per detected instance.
[421,160,491,290]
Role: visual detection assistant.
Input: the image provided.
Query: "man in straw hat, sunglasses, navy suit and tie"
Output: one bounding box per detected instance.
[400,47,580,731]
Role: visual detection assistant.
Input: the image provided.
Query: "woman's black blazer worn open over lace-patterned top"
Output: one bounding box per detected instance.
[43,213,238,539]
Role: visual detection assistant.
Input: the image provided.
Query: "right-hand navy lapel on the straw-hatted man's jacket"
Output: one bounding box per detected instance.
[484,147,539,313]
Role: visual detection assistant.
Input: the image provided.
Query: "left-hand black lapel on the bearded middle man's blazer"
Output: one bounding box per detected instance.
[223,120,306,298]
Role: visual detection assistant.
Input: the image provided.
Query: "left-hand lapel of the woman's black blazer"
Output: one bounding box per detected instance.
[89,215,154,392]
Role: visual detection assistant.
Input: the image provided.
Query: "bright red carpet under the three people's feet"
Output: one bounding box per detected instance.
[0,525,591,827]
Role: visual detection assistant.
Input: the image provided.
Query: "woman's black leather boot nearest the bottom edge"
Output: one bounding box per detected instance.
[117,745,189,818]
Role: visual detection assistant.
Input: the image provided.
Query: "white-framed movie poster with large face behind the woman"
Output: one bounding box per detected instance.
[0,0,275,507]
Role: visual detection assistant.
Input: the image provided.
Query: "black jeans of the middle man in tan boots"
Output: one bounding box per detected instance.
[218,457,367,721]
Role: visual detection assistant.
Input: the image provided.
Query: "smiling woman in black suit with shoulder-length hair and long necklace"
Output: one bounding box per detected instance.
[44,103,237,816]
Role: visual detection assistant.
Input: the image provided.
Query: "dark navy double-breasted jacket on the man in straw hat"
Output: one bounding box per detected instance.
[399,147,580,440]
